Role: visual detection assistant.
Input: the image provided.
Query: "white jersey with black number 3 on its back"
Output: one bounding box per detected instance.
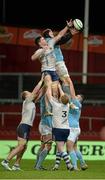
[50,98,69,129]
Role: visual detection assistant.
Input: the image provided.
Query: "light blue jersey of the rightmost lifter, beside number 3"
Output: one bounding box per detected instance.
[69,99,82,128]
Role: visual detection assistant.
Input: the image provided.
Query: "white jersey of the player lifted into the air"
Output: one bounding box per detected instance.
[39,40,56,72]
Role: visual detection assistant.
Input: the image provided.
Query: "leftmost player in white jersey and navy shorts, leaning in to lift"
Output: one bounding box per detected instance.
[1,79,43,171]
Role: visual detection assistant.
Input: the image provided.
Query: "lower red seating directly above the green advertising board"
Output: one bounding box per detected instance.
[0,104,105,140]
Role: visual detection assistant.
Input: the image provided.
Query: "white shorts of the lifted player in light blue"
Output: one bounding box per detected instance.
[56,61,69,78]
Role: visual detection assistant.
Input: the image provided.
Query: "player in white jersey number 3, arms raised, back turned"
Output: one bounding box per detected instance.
[46,84,73,170]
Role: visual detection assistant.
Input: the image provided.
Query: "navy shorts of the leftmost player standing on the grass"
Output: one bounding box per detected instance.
[17,124,31,140]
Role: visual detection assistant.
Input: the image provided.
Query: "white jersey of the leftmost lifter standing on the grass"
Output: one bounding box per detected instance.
[20,98,36,126]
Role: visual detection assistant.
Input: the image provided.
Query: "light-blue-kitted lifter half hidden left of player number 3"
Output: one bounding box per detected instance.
[34,95,52,170]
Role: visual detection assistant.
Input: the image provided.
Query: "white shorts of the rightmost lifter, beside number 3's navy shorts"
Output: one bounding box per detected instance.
[67,128,81,143]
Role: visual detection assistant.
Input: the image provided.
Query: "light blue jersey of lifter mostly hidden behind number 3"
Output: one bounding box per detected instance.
[40,96,52,128]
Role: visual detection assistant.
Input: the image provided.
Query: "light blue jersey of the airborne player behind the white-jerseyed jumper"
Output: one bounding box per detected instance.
[46,38,64,63]
